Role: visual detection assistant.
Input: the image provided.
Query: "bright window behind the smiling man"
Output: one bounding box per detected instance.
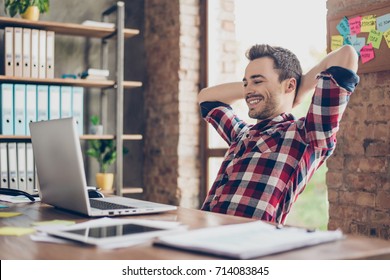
[204,0,328,228]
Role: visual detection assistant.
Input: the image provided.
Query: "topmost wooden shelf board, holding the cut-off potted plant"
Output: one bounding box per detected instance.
[0,17,139,38]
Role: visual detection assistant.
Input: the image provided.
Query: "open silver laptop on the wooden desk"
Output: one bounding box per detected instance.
[29,118,177,217]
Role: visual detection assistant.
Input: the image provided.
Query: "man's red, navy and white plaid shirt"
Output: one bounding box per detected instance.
[201,67,358,223]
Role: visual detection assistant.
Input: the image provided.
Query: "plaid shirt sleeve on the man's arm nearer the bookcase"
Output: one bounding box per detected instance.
[200,101,248,145]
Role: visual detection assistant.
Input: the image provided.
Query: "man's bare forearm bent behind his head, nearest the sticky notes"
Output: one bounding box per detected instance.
[293,45,359,107]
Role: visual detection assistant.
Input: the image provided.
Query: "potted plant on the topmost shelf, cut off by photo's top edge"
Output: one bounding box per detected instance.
[4,0,49,21]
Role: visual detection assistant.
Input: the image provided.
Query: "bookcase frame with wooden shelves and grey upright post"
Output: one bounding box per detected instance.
[0,1,142,195]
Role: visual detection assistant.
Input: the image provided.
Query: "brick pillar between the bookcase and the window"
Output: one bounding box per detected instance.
[144,0,200,208]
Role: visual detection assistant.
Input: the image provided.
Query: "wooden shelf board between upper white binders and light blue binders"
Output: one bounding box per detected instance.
[0,75,142,88]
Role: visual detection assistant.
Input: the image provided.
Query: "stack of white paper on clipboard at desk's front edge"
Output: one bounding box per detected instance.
[155,221,343,259]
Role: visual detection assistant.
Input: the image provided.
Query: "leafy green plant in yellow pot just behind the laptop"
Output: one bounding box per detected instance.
[87,139,117,191]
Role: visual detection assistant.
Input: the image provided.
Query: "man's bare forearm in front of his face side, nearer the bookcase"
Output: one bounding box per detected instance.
[198,82,244,105]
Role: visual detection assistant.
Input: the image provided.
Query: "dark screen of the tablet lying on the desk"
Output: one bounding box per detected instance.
[67,224,161,238]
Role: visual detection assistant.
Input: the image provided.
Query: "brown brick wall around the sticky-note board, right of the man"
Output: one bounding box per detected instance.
[326,0,390,239]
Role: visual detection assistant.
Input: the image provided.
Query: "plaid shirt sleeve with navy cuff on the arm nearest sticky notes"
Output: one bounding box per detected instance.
[305,67,359,150]
